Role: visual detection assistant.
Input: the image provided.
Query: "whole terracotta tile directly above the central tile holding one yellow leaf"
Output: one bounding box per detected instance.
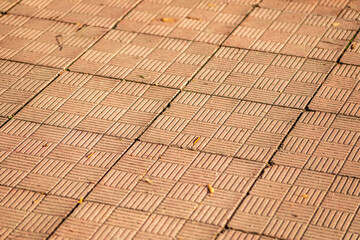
[185,47,332,108]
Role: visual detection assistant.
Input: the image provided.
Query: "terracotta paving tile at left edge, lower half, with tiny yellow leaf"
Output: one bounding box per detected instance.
[0,116,133,199]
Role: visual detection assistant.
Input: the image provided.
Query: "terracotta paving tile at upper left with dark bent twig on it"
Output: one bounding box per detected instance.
[0,14,106,67]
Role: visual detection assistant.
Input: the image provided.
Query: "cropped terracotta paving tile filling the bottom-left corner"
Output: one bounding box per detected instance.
[0,188,76,239]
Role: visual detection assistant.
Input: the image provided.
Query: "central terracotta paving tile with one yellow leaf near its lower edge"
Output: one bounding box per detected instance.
[141,92,300,157]
